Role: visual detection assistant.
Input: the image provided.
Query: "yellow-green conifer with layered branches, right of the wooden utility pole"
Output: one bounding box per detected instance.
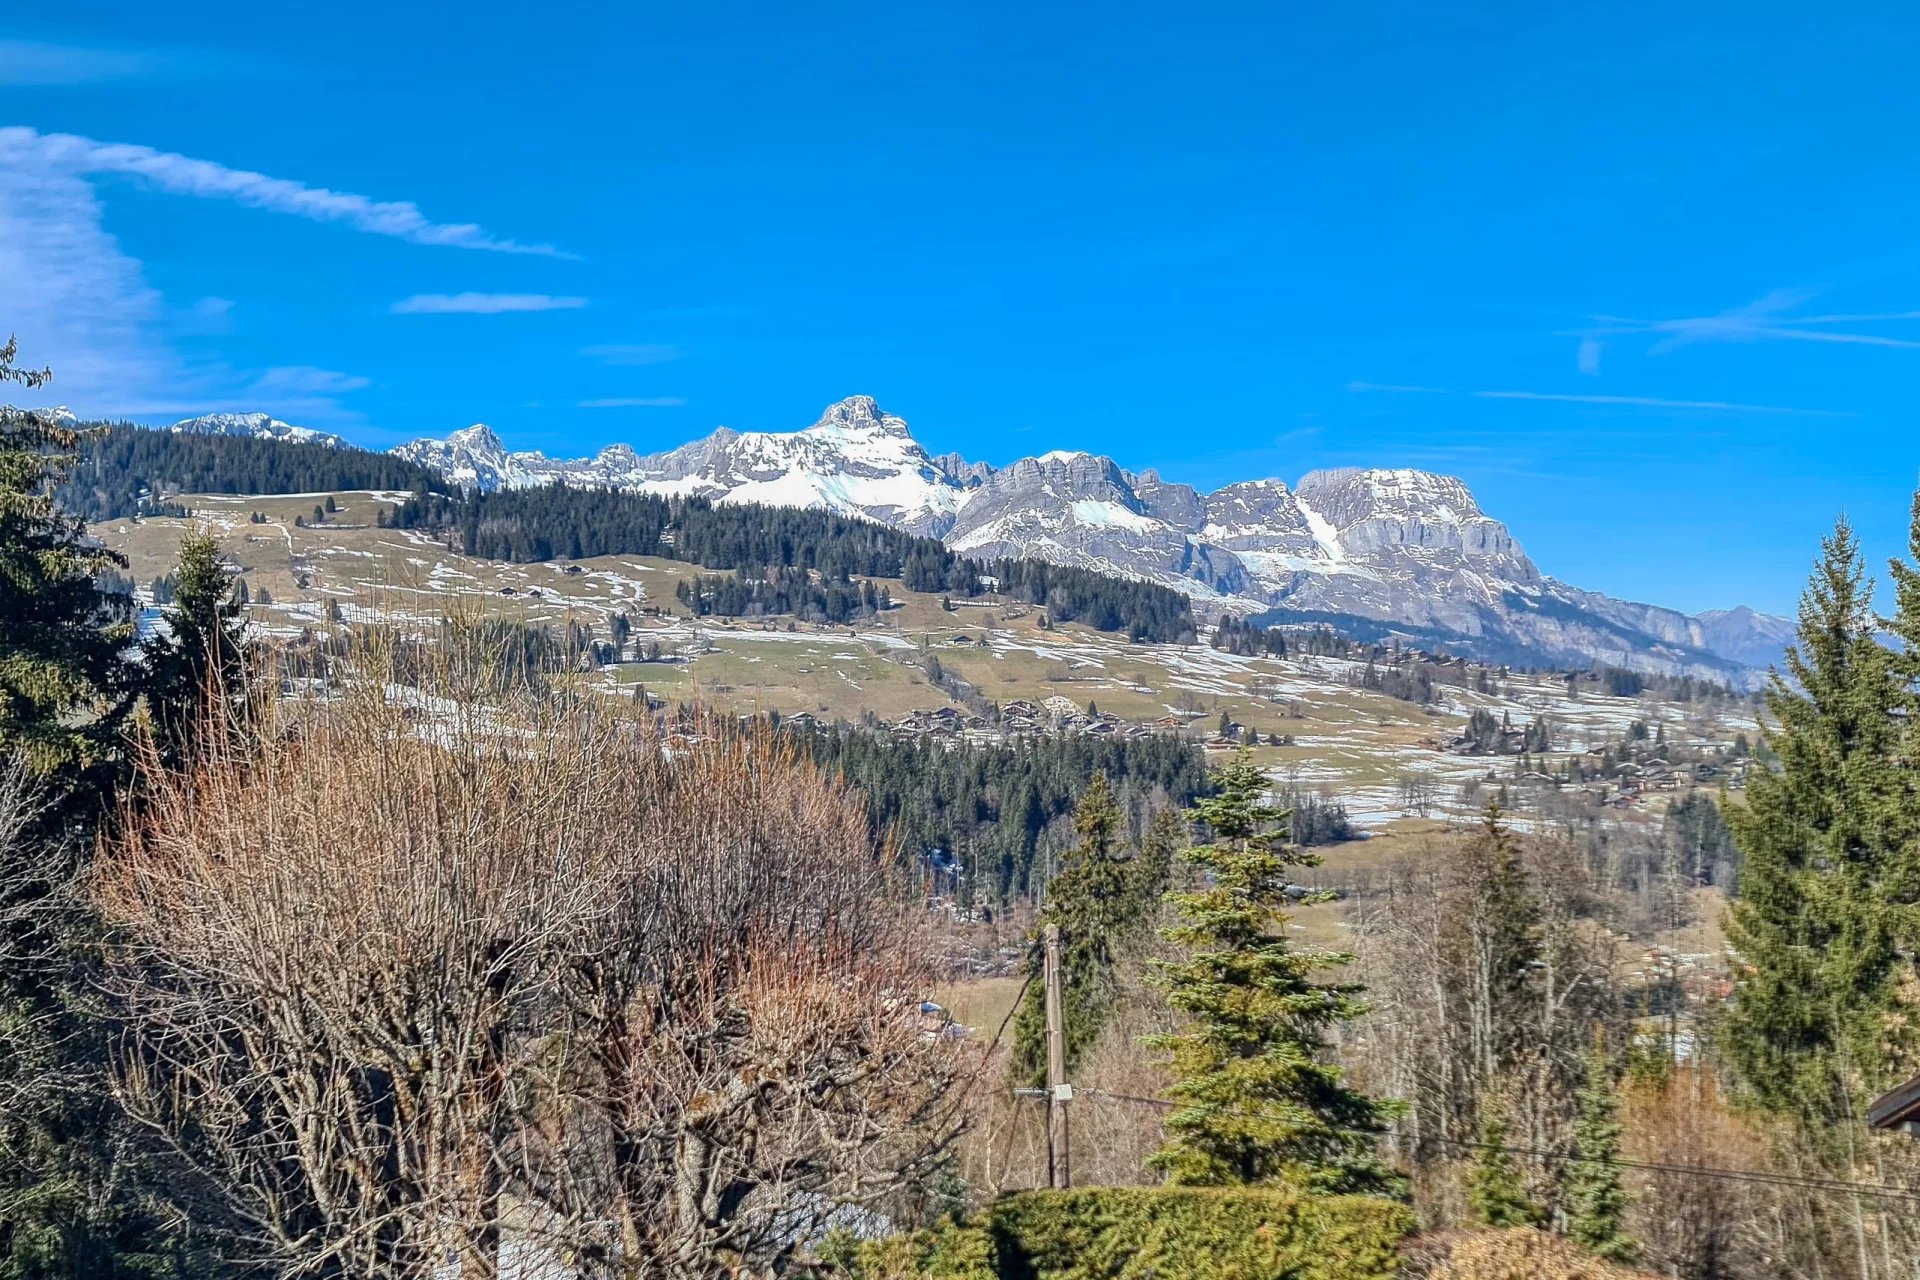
[1148,752,1402,1194]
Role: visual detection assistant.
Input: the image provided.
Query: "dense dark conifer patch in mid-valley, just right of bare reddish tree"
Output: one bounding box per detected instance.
[779,725,1206,902]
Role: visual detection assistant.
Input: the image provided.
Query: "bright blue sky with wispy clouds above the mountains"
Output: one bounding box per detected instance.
[0,0,1920,610]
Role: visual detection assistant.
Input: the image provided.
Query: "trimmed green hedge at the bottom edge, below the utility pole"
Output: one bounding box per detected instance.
[825,1188,1413,1280]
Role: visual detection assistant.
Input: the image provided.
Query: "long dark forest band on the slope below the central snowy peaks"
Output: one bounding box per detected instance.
[394,484,1194,643]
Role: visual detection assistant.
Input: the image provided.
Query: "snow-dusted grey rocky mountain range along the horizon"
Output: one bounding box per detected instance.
[175,395,1793,683]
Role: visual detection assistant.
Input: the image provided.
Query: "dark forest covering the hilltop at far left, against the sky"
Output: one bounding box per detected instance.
[54,422,442,520]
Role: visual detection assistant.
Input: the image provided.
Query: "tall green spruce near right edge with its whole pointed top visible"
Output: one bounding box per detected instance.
[1722,520,1912,1134]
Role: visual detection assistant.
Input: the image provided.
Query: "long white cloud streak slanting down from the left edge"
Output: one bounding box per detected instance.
[0,127,570,257]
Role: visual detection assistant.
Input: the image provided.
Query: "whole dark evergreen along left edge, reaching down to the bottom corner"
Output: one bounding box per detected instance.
[0,340,211,1280]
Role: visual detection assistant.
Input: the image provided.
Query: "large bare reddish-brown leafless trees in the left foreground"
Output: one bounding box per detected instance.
[96,664,954,1278]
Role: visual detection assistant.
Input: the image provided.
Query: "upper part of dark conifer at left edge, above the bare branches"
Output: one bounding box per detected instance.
[0,340,136,794]
